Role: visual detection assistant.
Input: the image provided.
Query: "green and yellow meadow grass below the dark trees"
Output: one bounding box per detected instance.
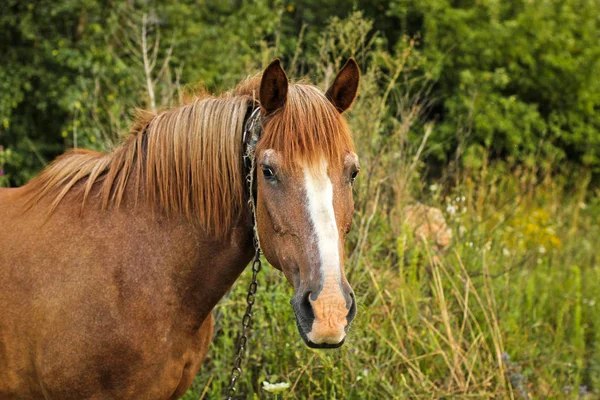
[193,164,600,400]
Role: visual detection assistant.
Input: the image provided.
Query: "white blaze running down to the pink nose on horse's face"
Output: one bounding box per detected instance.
[304,161,348,344]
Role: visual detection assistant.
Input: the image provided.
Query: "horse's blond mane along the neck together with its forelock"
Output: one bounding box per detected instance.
[25,78,353,236]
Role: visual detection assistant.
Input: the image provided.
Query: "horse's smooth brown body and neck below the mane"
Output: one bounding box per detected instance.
[0,189,253,399]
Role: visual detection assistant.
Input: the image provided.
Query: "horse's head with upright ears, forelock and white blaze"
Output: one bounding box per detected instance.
[256,59,360,348]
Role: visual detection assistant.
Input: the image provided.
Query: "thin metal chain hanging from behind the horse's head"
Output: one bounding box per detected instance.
[227,107,262,400]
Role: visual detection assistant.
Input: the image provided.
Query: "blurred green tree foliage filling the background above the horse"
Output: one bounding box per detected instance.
[0,0,600,185]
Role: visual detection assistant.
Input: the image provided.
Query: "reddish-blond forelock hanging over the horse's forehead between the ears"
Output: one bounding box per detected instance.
[258,84,354,172]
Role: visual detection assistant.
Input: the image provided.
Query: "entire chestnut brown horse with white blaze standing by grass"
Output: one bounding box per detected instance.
[0,59,359,399]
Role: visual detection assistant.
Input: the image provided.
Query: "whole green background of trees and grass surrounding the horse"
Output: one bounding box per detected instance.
[0,0,600,399]
